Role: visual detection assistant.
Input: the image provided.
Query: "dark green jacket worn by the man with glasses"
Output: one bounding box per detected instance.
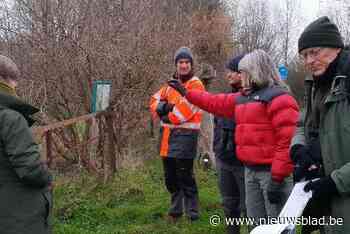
[292,50,350,234]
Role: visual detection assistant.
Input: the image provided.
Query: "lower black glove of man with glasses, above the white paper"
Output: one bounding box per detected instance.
[304,176,339,199]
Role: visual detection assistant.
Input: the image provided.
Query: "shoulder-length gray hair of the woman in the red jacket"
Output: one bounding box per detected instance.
[238,49,287,89]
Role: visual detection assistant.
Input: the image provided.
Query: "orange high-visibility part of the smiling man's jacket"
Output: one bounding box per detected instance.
[150,77,205,157]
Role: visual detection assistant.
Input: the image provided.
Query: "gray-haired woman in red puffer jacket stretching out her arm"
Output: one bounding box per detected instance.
[169,50,299,229]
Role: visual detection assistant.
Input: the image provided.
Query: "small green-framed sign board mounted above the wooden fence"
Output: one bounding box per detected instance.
[91,80,112,112]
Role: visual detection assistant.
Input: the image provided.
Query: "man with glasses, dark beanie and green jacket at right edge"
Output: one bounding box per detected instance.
[291,17,350,234]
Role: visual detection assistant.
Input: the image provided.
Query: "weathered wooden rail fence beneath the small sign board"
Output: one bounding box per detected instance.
[32,111,117,182]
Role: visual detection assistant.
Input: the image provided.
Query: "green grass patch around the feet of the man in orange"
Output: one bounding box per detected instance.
[53,159,247,234]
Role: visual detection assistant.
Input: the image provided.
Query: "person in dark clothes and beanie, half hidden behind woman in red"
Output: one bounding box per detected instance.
[213,55,246,234]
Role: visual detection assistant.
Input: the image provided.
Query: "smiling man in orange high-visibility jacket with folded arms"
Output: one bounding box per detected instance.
[150,47,205,222]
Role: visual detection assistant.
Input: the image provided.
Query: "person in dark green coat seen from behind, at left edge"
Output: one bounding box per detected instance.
[0,55,52,234]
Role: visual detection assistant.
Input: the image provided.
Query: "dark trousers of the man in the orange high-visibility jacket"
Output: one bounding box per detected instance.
[163,158,199,220]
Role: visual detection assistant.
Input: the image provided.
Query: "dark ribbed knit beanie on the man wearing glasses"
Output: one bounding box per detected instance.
[298,16,344,53]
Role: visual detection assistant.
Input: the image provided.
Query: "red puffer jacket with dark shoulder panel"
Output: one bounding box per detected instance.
[186,87,299,181]
